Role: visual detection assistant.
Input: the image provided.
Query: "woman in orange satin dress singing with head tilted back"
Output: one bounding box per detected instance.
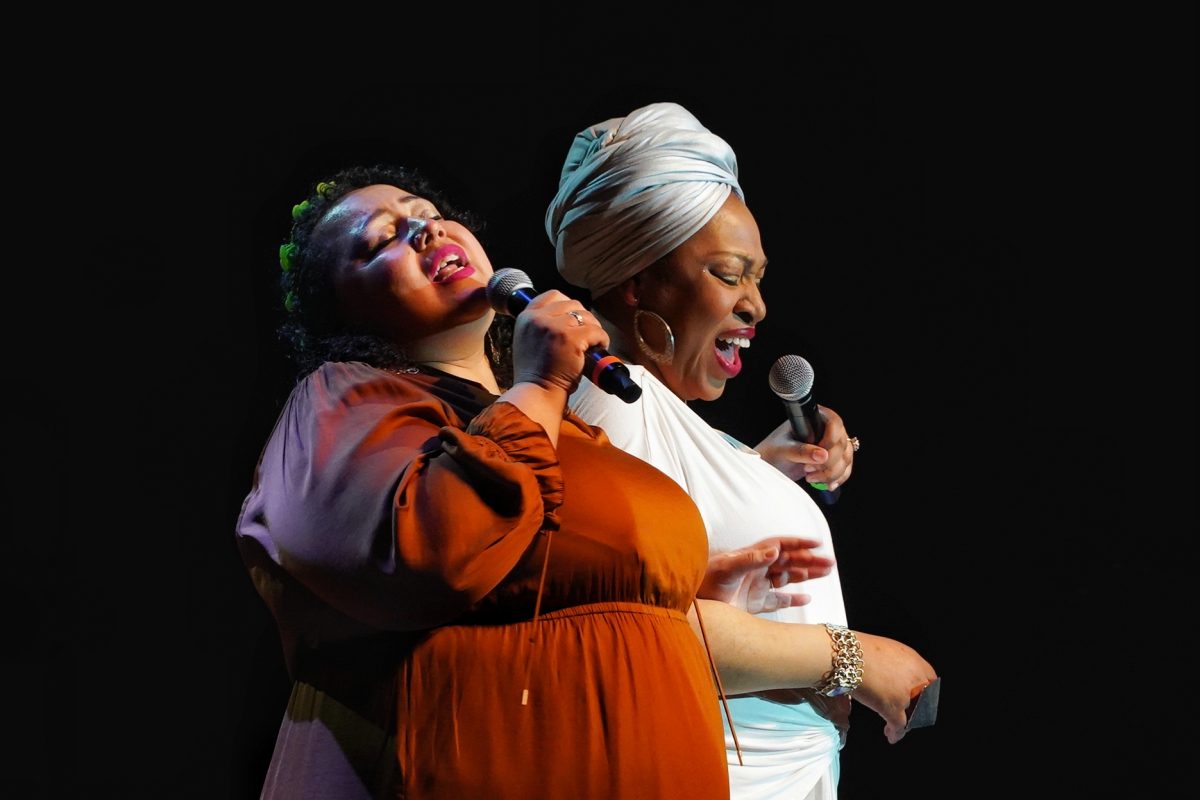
[236,168,728,800]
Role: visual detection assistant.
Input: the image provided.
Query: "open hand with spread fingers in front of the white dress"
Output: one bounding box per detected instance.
[696,536,833,614]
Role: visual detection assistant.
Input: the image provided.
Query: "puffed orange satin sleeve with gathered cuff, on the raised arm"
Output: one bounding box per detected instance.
[238,363,563,630]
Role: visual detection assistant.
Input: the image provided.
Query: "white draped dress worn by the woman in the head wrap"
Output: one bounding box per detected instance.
[570,363,846,799]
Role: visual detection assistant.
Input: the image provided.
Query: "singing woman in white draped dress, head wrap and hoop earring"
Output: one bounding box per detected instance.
[546,103,936,800]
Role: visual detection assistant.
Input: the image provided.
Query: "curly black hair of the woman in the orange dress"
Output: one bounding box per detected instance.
[278,164,512,385]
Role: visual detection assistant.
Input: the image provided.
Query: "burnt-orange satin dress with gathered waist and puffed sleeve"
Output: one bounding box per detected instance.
[238,362,728,800]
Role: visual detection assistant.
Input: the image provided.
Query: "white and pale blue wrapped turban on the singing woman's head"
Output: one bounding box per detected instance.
[546,103,745,297]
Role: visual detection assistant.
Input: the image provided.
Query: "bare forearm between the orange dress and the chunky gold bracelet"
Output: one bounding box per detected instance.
[688,600,833,694]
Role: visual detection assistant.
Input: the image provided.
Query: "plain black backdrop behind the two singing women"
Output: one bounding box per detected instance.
[23,14,1196,798]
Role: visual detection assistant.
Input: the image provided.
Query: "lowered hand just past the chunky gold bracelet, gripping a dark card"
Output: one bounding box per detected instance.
[851,631,937,745]
